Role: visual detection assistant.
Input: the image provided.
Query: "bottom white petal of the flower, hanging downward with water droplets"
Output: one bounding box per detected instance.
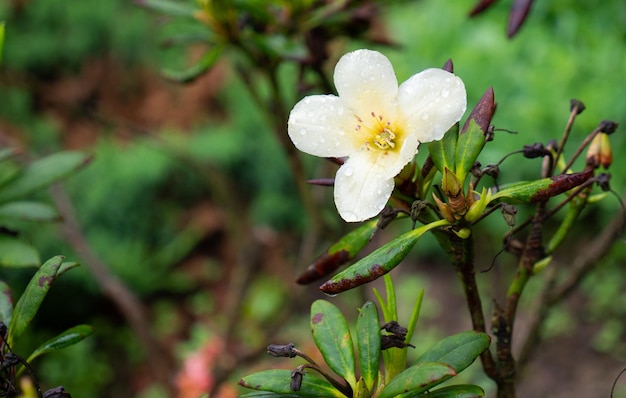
[335,151,394,222]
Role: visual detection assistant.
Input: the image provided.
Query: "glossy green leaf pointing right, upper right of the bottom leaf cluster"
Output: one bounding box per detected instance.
[417,330,491,373]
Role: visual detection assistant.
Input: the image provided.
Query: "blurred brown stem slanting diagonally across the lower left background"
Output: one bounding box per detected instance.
[51,184,174,393]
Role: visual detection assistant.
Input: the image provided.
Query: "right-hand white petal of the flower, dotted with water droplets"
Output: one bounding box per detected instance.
[398,69,467,142]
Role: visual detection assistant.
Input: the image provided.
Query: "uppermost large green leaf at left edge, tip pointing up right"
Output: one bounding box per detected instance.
[0,151,91,202]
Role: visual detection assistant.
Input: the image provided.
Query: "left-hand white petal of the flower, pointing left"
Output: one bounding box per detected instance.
[287,95,362,157]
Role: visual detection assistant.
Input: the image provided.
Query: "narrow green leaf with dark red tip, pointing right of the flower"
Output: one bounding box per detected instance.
[491,169,593,203]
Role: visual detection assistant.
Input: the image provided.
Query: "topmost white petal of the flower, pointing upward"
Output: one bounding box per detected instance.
[334,50,398,118]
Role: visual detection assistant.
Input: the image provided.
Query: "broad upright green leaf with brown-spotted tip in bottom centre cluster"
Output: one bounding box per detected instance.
[311,300,356,390]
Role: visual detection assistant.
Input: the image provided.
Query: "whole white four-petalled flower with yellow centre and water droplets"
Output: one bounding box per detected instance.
[288,50,467,222]
